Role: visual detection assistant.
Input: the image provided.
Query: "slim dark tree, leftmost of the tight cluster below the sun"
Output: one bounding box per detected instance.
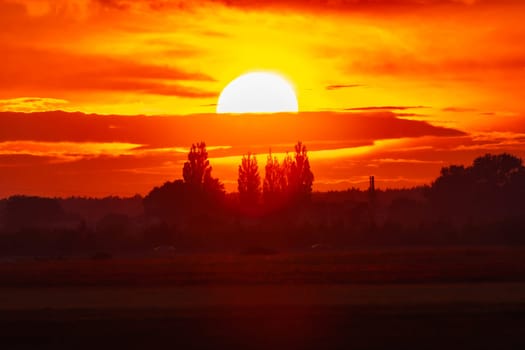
[237,153,261,205]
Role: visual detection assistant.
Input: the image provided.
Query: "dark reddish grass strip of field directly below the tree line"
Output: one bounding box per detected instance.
[0,247,525,287]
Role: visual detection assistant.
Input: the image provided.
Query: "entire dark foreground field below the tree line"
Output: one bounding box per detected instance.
[0,248,525,349]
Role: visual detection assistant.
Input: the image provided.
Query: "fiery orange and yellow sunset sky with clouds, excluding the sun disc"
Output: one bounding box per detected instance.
[0,0,525,197]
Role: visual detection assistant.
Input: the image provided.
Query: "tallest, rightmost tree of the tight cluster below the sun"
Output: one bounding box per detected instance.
[288,141,314,200]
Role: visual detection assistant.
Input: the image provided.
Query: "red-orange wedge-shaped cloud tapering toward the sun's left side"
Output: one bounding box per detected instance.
[0,47,217,98]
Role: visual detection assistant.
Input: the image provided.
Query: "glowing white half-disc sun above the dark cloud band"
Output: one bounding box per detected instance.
[217,72,299,113]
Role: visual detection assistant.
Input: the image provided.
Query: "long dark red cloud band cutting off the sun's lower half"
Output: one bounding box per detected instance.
[0,112,464,148]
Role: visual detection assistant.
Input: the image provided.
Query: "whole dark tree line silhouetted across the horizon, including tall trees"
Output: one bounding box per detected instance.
[0,149,525,255]
